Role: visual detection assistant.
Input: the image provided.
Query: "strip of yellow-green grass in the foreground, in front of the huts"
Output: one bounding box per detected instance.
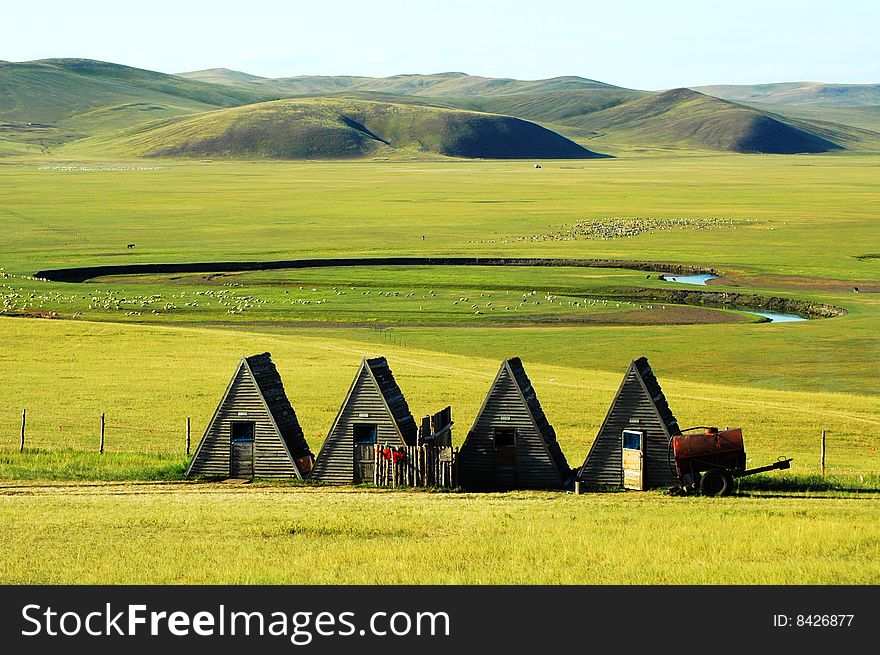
[0,484,880,584]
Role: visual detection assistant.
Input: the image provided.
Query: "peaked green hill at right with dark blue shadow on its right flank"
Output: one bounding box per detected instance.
[565,89,841,154]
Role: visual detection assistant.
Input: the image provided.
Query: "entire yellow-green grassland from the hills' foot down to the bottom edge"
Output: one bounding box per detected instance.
[0,154,880,583]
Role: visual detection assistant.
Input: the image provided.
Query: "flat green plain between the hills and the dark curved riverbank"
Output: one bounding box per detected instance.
[0,154,880,281]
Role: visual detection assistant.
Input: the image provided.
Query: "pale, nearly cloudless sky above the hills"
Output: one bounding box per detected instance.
[0,0,880,90]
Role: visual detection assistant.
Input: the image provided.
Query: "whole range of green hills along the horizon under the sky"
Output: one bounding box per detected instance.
[0,59,880,158]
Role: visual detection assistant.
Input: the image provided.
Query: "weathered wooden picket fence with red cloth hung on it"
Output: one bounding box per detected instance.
[373,445,458,489]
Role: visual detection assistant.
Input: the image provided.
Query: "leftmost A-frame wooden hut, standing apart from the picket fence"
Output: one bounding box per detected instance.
[186,353,314,479]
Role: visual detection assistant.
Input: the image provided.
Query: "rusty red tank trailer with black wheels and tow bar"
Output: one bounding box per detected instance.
[670,426,791,496]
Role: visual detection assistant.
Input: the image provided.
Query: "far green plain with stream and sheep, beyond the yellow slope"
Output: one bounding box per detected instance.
[0,155,880,394]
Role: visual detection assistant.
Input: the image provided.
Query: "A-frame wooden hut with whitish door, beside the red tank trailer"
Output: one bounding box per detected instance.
[577,357,680,489]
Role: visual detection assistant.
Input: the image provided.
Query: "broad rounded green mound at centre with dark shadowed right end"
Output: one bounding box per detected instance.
[72,98,601,159]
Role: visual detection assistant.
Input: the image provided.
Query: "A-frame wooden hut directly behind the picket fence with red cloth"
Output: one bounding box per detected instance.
[311,357,418,484]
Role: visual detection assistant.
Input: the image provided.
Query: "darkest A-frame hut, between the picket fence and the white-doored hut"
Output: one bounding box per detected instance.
[457,357,570,490]
